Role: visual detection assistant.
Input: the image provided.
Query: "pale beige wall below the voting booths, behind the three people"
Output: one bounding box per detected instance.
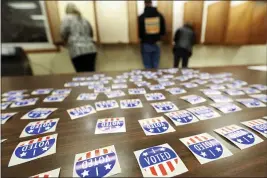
[28,45,267,75]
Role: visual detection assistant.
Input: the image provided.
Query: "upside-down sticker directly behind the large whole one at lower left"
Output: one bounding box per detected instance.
[20,119,59,138]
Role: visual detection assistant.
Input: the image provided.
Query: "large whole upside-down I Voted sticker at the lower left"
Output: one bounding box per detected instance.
[8,134,57,167]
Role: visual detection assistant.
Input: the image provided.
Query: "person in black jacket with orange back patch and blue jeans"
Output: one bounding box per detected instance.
[138,0,165,69]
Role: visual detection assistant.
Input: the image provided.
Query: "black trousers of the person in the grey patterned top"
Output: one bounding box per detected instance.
[72,53,96,72]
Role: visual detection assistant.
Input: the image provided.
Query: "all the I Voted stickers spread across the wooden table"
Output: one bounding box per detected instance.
[1,69,267,177]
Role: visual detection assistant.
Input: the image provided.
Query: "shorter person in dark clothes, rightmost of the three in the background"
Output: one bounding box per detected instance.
[173,24,196,68]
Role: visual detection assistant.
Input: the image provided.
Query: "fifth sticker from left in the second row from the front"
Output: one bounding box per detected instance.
[187,106,221,120]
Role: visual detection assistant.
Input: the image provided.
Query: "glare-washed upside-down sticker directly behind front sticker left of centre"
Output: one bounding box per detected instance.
[95,117,126,134]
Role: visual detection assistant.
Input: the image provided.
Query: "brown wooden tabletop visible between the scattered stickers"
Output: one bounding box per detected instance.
[1,66,267,177]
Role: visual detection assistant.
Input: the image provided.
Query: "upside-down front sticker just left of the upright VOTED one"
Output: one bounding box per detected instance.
[73,145,121,177]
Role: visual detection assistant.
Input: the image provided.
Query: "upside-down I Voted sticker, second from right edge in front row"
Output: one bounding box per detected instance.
[214,125,263,150]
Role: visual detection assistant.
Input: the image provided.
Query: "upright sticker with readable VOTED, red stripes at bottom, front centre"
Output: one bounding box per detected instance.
[134,143,188,177]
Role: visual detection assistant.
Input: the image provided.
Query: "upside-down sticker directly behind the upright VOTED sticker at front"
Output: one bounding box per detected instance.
[138,117,175,135]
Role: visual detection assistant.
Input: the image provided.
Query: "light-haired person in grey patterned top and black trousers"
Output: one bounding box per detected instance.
[60,3,97,72]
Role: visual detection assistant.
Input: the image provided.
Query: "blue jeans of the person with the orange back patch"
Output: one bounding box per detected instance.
[141,43,160,69]
